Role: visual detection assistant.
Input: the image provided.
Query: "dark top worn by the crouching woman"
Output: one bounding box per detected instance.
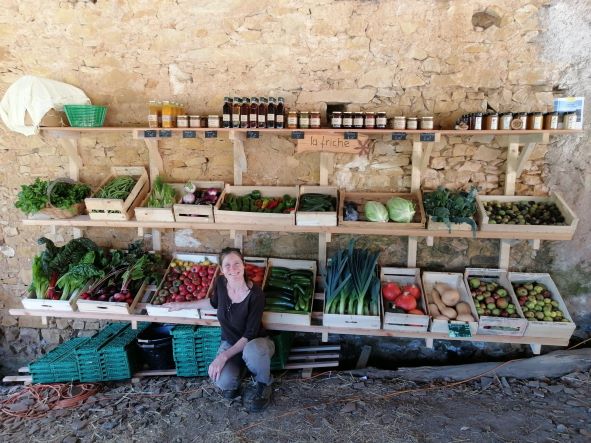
[210,275,267,345]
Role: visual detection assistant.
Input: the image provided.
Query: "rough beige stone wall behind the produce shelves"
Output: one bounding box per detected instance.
[0,0,591,374]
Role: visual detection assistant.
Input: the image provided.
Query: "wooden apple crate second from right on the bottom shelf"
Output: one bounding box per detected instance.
[464,268,527,337]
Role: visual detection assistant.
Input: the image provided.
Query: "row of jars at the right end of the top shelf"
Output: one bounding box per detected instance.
[456,112,577,131]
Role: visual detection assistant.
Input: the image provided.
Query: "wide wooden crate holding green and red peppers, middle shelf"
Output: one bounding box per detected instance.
[213,185,299,226]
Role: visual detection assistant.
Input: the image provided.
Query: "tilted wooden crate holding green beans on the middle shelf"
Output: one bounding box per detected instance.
[84,166,150,220]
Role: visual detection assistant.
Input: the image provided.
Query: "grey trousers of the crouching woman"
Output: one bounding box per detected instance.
[215,337,275,391]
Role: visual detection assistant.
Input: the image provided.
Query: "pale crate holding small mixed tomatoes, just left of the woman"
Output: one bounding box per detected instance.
[146,253,219,319]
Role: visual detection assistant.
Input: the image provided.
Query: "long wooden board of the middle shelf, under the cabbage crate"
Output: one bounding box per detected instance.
[22,215,572,241]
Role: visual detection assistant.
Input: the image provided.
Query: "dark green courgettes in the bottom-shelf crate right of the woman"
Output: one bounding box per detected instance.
[264,266,314,314]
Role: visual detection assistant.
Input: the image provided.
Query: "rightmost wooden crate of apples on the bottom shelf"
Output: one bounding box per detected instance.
[507,272,576,339]
